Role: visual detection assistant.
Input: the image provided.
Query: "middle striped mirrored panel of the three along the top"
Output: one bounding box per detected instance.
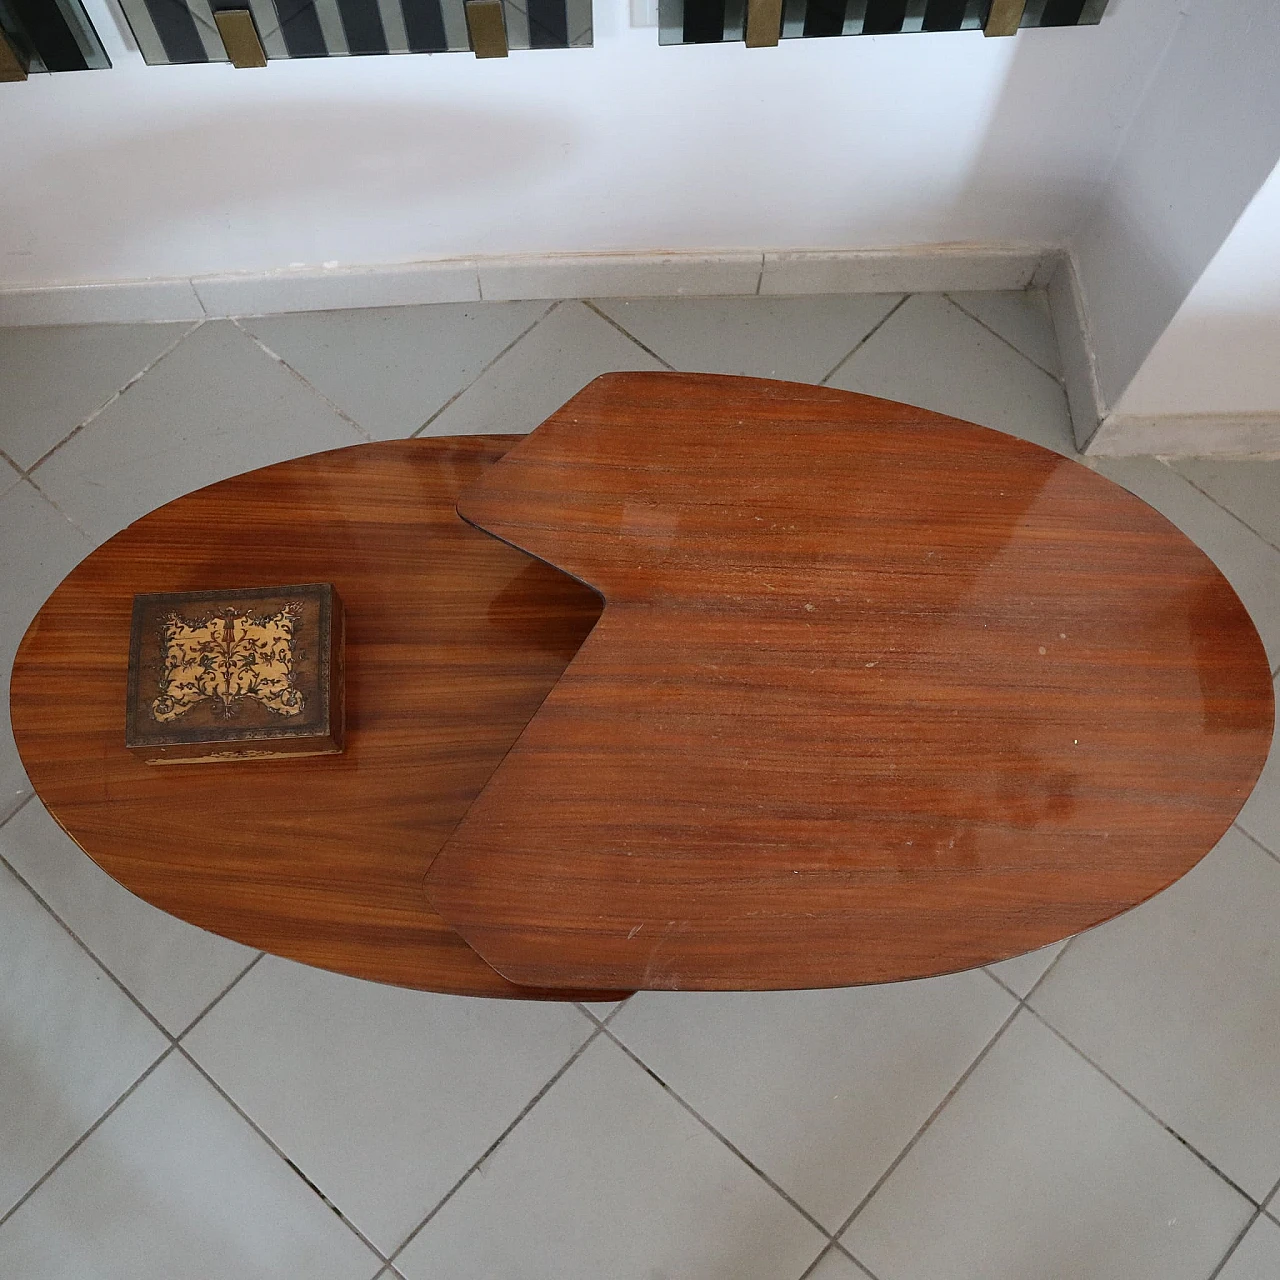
[120,0,591,64]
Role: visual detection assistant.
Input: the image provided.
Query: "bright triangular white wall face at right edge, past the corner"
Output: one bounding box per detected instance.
[1116,166,1280,416]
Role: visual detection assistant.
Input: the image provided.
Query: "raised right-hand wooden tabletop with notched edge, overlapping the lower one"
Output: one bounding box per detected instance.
[428,374,1272,989]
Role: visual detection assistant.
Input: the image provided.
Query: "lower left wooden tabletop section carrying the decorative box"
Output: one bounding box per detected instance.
[12,436,622,998]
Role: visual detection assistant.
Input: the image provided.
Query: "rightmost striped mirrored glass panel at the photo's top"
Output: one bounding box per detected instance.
[658,0,1107,45]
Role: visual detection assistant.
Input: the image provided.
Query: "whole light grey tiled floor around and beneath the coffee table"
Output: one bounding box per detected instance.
[0,294,1280,1280]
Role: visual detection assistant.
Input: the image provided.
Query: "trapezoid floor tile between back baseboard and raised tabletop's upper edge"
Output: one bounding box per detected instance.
[596,293,901,383]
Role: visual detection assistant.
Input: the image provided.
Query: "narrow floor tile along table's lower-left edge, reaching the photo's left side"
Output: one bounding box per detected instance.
[0,800,256,1036]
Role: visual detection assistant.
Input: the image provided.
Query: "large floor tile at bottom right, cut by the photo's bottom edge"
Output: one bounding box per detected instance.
[842,1012,1251,1280]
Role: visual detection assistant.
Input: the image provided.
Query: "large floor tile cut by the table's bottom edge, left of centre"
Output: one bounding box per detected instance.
[184,956,591,1251]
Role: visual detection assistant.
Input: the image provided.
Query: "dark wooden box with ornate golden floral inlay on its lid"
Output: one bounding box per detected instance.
[124,582,344,764]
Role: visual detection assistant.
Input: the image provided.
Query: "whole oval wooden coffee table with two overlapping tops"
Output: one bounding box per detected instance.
[13,374,1272,998]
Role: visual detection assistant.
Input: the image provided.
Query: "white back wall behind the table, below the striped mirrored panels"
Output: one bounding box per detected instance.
[0,0,1177,288]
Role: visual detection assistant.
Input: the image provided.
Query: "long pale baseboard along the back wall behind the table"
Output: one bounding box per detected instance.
[0,244,1052,325]
